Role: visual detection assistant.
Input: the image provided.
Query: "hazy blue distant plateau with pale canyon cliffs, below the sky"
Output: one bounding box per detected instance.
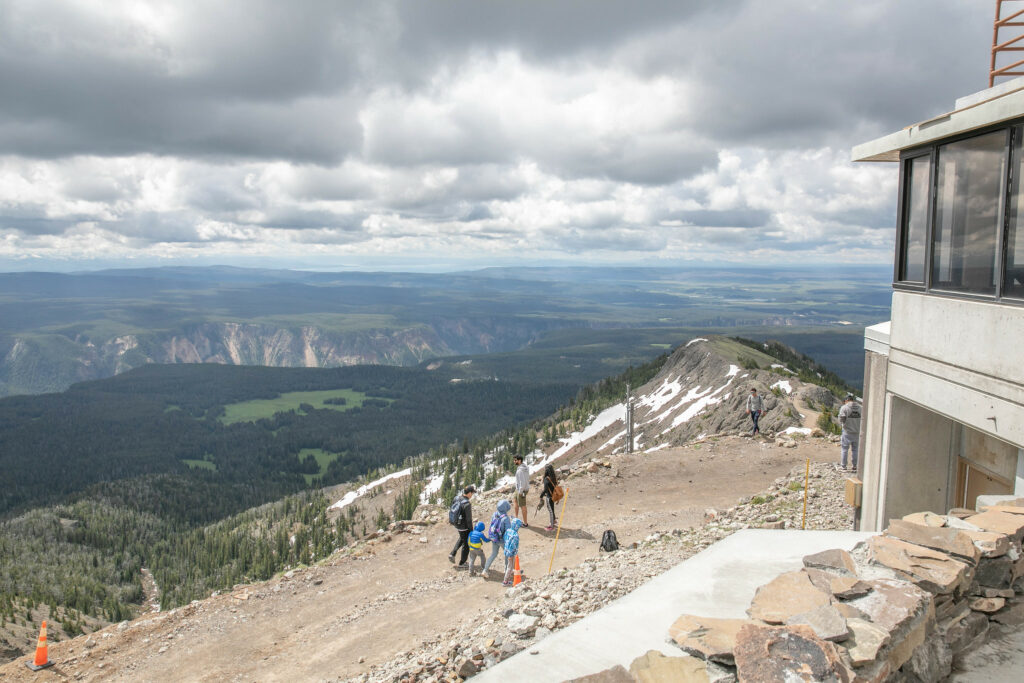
[0,267,890,395]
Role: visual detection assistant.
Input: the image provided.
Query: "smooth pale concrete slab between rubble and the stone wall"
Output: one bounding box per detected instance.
[474,529,873,683]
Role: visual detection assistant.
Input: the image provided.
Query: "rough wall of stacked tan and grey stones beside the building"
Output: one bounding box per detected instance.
[651,499,1024,682]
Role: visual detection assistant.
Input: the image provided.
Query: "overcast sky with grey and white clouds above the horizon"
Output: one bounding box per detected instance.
[0,0,994,269]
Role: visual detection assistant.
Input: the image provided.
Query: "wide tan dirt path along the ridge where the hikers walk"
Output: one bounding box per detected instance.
[0,437,837,682]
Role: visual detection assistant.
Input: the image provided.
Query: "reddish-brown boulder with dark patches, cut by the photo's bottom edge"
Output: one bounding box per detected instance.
[735,625,853,683]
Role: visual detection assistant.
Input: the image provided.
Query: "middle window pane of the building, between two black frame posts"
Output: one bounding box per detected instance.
[932,130,1007,294]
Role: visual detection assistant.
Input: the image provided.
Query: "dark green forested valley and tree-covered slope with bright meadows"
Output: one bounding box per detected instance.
[0,355,667,651]
